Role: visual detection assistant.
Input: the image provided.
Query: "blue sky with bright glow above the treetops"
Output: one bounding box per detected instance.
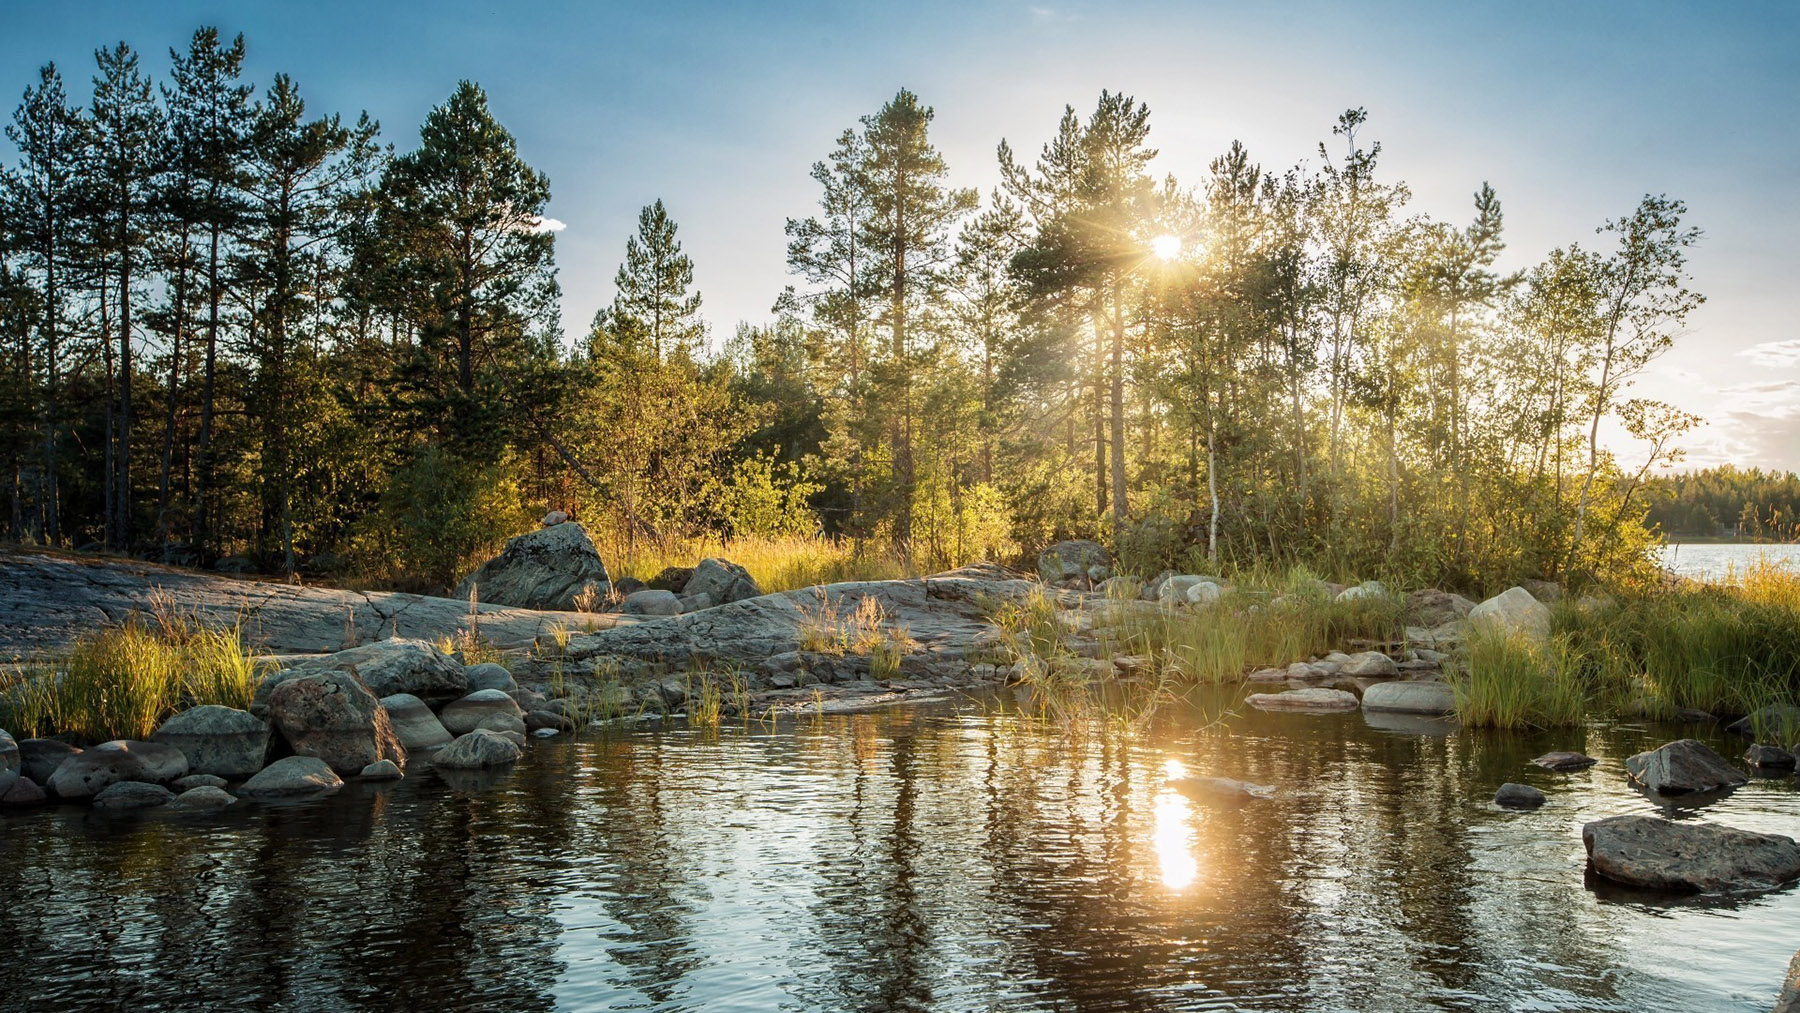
[0,0,1800,468]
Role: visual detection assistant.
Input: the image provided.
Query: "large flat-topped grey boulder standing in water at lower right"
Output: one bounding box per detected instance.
[1580,815,1800,892]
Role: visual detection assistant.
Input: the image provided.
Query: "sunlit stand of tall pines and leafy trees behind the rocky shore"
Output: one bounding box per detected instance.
[0,29,1713,590]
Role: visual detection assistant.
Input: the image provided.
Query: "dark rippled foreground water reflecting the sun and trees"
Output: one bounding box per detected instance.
[0,705,1800,1013]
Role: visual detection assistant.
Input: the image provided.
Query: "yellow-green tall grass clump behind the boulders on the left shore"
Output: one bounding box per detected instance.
[0,599,257,741]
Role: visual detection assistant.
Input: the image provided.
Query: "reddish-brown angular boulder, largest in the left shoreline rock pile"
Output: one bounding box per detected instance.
[268,671,407,774]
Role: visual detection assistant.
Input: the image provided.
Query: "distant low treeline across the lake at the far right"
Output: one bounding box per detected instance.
[1647,464,1800,542]
